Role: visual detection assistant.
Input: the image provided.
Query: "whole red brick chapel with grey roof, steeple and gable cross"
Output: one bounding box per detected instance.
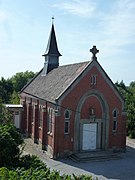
[20,23,127,158]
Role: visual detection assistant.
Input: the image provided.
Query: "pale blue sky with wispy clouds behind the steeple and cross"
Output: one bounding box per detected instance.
[0,0,135,85]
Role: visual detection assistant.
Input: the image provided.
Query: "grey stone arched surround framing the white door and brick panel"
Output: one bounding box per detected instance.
[74,90,109,152]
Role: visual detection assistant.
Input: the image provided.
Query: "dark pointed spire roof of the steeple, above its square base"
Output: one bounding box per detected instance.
[43,24,61,56]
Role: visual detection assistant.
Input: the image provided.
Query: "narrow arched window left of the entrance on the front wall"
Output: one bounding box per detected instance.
[64,110,70,134]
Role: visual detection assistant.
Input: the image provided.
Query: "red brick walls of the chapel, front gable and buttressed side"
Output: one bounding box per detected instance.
[21,58,126,158]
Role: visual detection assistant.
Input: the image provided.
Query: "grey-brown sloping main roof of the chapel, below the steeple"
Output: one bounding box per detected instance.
[21,62,90,102]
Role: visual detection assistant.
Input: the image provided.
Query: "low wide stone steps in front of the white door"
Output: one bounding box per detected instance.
[70,151,121,162]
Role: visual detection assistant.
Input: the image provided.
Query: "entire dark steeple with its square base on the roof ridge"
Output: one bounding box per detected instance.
[42,17,62,75]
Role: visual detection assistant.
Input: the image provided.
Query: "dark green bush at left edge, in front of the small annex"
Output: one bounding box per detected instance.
[0,99,23,167]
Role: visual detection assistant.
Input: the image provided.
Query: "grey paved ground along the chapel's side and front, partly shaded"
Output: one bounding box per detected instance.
[25,138,135,180]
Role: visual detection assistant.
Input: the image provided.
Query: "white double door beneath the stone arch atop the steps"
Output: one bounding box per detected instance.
[82,123,97,150]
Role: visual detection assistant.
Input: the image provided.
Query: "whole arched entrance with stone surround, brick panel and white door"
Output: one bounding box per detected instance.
[74,90,109,151]
